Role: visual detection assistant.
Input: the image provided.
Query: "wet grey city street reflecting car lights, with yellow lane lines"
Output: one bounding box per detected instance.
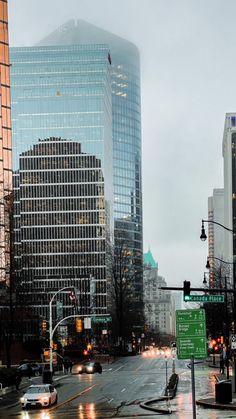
[0,356,236,419]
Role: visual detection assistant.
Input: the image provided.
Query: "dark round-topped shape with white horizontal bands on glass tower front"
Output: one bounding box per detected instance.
[14,138,112,319]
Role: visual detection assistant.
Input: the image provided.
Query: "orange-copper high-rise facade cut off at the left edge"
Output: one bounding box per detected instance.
[0,0,12,282]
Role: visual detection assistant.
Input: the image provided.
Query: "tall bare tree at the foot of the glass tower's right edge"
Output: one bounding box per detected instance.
[106,237,144,350]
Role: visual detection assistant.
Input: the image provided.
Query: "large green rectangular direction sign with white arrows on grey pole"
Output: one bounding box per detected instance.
[176,309,207,359]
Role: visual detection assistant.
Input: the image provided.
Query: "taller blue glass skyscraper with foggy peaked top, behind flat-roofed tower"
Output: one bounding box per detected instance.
[38,20,143,295]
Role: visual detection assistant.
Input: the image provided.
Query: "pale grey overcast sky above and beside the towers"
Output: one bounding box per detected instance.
[9,0,236,286]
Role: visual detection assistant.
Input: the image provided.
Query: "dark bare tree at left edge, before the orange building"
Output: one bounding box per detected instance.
[0,192,42,367]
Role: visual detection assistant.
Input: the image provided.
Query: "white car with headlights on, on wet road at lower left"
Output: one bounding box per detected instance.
[20,384,57,408]
